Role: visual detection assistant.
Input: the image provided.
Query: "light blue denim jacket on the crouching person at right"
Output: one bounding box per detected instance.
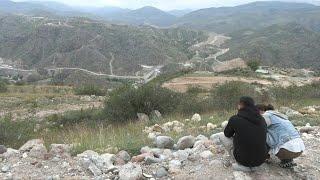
[263,111,300,149]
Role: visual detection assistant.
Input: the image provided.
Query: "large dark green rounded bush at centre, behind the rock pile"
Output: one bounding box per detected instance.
[104,84,182,122]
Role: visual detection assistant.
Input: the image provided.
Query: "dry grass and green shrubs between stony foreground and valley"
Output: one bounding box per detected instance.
[0,79,320,154]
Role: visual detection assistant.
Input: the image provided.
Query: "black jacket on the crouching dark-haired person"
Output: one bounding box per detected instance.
[224,107,268,167]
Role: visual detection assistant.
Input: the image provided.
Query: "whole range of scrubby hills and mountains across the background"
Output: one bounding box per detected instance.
[0,0,320,74]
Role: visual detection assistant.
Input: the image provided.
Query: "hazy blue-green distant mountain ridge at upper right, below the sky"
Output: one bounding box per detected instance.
[176,2,320,33]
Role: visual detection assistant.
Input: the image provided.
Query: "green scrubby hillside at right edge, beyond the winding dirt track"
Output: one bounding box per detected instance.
[221,23,320,69]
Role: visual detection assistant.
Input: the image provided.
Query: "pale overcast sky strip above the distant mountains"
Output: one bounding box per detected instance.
[13,0,320,10]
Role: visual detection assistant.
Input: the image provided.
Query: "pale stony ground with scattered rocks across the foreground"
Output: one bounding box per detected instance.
[0,115,320,180]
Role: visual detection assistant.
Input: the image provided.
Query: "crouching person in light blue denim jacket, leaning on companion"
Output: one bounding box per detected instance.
[257,105,305,168]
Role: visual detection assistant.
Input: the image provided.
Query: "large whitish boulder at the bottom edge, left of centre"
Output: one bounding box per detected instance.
[119,162,143,180]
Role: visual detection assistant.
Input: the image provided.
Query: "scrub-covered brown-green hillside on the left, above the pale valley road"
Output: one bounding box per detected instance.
[0,15,206,75]
